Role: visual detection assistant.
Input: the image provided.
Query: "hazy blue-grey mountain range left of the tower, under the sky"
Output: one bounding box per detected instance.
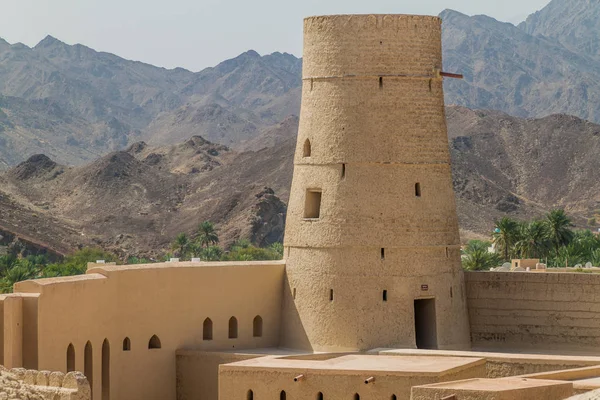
[0,36,301,168]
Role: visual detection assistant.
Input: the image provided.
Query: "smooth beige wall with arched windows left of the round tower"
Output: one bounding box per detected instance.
[4,261,284,400]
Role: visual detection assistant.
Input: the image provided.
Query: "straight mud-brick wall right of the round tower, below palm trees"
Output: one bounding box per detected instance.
[465,272,600,354]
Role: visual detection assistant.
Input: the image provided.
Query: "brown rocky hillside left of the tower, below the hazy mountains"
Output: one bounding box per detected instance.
[0,136,294,257]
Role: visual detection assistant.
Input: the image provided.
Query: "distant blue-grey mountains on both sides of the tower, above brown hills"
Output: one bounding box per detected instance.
[0,0,600,169]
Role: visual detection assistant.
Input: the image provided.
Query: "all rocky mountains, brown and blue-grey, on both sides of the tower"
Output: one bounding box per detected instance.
[5,0,600,255]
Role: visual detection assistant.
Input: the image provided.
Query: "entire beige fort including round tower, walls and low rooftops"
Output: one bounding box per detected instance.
[0,10,600,400]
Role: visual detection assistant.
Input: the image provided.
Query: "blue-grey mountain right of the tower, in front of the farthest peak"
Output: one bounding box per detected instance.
[441,4,600,122]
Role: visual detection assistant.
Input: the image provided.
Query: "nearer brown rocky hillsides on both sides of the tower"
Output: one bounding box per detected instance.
[0,107,600,256]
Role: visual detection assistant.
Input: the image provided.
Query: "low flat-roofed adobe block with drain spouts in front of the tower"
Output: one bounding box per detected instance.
[219,355,485,400]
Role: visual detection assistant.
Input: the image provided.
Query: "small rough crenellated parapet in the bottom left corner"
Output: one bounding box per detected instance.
[0,367,92,400]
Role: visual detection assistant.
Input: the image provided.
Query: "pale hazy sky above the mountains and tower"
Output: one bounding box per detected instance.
[0,0,549,71]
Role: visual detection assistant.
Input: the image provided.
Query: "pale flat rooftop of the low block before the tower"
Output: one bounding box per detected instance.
[227,354,485,375]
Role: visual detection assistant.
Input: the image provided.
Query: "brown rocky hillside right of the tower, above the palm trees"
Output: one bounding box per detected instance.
[447,107,600,239]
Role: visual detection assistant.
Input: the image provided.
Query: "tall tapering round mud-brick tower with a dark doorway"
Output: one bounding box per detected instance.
[282,15,470,351]
